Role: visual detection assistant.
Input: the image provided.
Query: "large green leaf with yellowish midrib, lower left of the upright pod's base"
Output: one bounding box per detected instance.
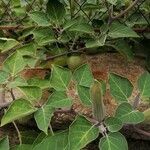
[68,116,99,150]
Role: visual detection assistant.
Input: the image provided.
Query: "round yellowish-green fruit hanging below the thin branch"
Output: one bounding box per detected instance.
[67,55,85,70]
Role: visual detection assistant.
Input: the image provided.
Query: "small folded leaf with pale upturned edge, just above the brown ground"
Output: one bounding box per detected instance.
[85,35,107,48]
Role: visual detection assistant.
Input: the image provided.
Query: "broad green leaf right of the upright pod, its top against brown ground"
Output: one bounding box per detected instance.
[109,73,133,102]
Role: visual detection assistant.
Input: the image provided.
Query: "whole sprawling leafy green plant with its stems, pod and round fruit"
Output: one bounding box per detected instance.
[0,0,150,150]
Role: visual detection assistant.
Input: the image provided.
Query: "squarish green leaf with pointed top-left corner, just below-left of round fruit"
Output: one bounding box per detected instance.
[50,65,72,91]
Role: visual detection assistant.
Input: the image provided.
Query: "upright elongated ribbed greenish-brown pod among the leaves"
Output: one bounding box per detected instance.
[90,80,105,122]
